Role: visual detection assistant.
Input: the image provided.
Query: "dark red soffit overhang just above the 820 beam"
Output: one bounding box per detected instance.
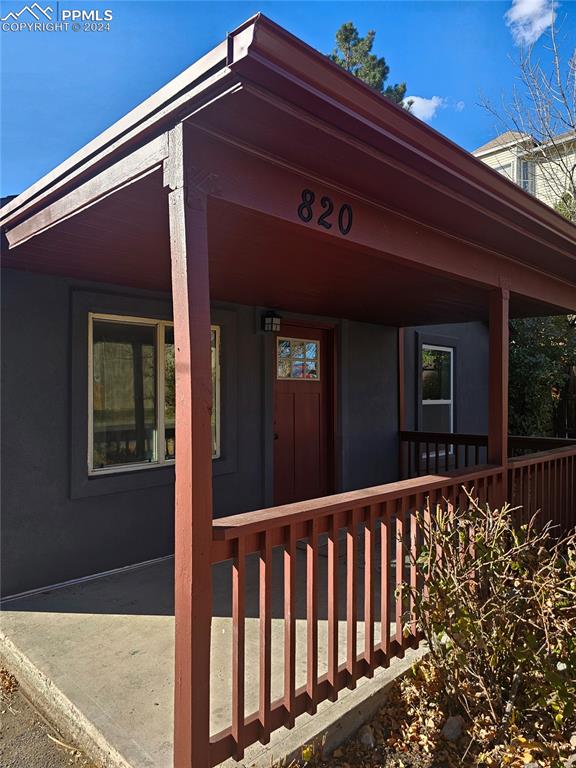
[194,83,576,283]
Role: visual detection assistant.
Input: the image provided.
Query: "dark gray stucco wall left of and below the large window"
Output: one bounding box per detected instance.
[0,271,174,594]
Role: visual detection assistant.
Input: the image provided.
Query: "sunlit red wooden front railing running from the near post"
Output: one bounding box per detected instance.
[211,467,503,765]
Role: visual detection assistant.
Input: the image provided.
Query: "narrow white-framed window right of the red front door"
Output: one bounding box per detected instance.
[422,344,454,432]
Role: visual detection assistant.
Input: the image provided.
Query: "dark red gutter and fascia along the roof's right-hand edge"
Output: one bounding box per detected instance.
[228,14,576,246]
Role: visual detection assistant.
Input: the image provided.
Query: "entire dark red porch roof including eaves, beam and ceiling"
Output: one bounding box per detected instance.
[0,14,576,324]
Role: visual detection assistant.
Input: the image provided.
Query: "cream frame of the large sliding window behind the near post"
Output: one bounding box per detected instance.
[87,312,221,477]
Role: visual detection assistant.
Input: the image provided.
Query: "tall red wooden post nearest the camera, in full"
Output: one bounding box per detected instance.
[164,124,212,768]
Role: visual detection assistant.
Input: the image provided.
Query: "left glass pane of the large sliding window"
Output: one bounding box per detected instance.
[92,320,156,469]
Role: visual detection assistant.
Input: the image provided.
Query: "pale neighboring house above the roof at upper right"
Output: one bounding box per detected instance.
[472,131,576,213]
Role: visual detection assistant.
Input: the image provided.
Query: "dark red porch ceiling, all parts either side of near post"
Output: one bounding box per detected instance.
[3,170,556,326]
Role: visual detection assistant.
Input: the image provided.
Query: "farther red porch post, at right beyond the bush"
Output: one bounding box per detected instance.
[488,288,510,503]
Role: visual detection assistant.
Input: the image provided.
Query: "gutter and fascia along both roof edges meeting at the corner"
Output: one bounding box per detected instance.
[1,14,576,258]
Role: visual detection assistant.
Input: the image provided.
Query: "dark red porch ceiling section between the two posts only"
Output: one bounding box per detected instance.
[209,202,488,325]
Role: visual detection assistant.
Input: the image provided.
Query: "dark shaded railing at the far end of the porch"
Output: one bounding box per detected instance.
[400,430,576,478]
